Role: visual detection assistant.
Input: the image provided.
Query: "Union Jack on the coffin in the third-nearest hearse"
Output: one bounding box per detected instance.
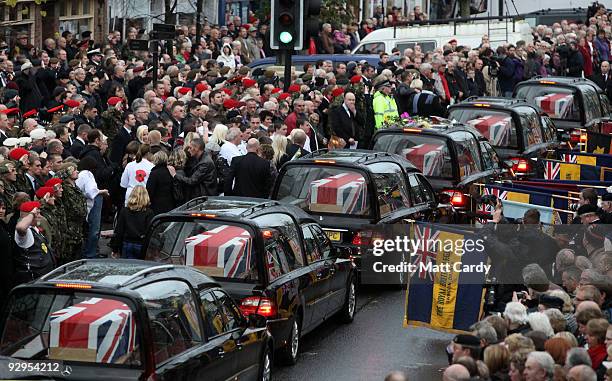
[309,172,367,214]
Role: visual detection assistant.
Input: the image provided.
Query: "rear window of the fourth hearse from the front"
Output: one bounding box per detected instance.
[373,134,453,178]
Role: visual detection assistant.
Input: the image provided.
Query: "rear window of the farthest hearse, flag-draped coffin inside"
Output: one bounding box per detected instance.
[516,83,582,121]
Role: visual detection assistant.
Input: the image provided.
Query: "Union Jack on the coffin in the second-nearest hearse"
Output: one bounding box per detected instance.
[185,225,252,278]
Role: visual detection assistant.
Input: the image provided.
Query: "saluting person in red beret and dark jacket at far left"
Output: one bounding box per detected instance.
[13,201,55,284]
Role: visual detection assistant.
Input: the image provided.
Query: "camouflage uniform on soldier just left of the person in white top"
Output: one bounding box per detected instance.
[61,182,87,262]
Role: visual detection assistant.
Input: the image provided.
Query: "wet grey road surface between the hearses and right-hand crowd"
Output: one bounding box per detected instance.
[273,286,452,381]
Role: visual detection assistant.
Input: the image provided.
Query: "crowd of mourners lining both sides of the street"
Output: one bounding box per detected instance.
[0,3,612,381]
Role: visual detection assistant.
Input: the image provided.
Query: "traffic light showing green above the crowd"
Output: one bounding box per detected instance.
[270,0,304,50]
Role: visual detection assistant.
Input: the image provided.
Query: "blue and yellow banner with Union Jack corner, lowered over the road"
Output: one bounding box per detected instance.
[404,223,489,332]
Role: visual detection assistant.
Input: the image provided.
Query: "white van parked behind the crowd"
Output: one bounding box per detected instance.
[352,20,533,54]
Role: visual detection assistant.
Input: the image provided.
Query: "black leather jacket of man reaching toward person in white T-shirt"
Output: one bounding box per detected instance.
[175,153,218,200]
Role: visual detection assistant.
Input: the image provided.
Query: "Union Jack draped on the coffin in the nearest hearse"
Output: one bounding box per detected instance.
[49,298,136,363]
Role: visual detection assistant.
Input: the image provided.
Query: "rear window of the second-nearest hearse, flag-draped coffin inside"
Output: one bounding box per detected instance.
[146,219,258,281]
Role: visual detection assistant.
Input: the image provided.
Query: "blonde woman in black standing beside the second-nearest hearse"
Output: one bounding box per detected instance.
[110,185,154,259]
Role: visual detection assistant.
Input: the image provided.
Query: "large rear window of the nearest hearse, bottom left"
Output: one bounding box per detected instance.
[0,289,142,367]
